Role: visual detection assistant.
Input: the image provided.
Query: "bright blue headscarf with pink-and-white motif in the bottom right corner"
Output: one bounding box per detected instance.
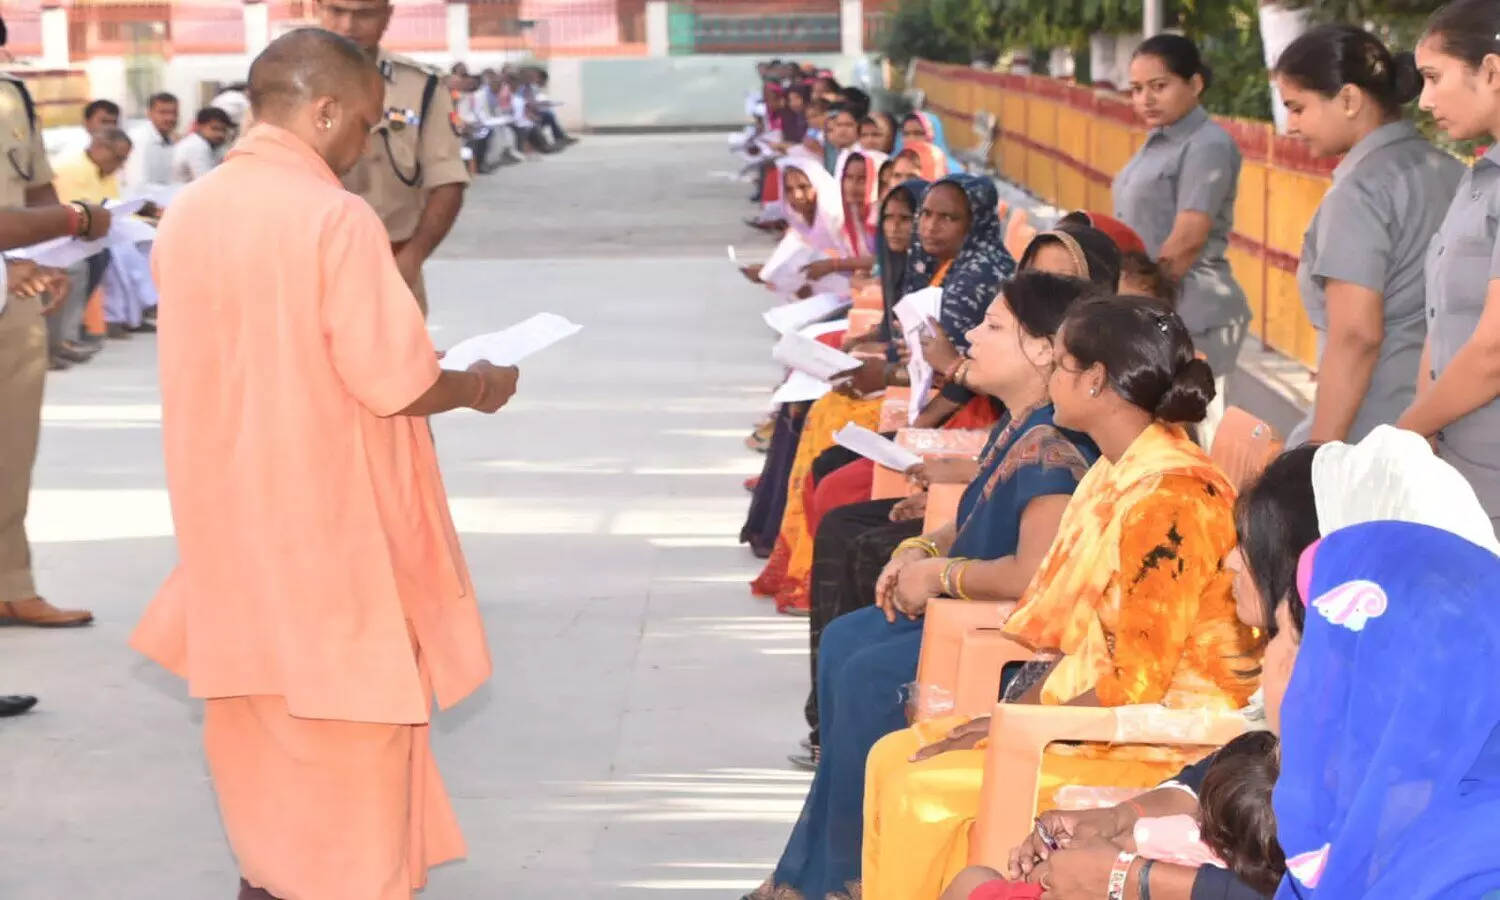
[1274,522,1500,900]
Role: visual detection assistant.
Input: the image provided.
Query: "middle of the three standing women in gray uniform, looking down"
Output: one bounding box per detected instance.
[1274,26,1464,446]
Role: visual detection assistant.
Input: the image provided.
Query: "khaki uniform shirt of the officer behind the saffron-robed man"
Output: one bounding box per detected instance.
[344,50,470,245]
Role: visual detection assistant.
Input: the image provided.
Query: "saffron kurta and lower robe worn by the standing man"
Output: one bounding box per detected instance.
[132,125,491,900]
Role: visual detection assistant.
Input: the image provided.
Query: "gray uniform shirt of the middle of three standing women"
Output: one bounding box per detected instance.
[1287,122,1464,446]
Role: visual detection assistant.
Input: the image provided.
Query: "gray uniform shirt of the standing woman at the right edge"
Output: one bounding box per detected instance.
[1427,146,1500,522]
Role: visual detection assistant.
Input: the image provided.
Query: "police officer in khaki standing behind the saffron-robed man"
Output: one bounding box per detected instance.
[318,0,470,315]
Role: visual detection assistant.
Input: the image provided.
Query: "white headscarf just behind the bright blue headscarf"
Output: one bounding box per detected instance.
[1313,425,1500,555]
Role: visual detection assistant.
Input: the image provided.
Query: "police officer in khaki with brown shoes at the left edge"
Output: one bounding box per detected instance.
[0,49,110,642]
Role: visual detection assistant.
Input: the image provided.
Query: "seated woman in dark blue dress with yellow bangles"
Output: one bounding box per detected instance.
[755,273,1097,899]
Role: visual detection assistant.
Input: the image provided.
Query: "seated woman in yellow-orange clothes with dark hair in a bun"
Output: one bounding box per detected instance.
[864,296,1254,900]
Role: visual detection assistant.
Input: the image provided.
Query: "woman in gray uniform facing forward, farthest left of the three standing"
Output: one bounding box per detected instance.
[1115,35,1250,444]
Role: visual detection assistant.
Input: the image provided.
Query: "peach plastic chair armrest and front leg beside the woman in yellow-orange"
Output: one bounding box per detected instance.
[969,704,1247,870]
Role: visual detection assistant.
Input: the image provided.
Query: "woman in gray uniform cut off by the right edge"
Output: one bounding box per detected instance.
[1398,0,1500,521]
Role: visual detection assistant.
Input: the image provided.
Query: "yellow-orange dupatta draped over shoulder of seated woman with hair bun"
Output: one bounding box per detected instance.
[1005,423,1235,704]
